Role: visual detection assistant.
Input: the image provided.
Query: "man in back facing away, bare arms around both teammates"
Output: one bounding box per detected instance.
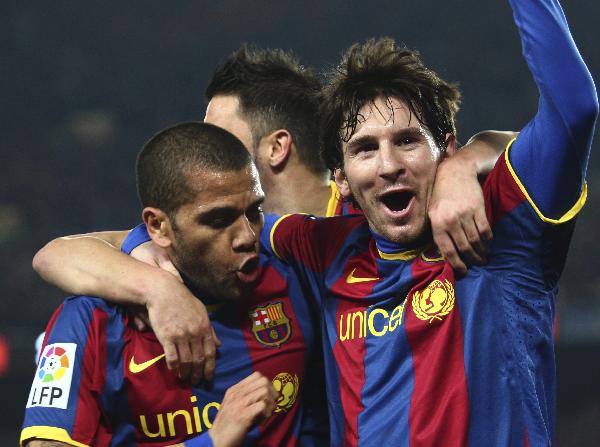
[34,46,512,382]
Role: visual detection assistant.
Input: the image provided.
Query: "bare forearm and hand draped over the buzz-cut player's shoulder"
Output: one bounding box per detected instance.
[33,232,218,383]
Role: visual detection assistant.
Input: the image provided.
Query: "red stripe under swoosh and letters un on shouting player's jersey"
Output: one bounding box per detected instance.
[331,253,379,445]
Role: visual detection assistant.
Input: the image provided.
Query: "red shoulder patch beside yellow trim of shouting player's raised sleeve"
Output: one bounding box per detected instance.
[483,154,526,225]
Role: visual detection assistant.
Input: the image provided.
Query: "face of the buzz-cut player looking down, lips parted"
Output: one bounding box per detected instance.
[169,165,264,301]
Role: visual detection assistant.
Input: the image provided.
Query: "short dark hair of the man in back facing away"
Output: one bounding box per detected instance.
[205,44,327,173]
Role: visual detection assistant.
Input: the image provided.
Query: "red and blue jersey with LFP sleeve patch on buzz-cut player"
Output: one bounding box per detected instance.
[21,260,327,446]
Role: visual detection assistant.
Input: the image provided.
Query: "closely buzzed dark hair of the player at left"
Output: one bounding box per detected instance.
[136,122,252,217]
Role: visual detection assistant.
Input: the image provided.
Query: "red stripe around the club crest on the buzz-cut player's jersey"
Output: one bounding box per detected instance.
[239,266,306,446]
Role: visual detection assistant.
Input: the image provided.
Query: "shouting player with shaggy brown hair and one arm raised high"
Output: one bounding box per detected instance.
[263,0,598,446]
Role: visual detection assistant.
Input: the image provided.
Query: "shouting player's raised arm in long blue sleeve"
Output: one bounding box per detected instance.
[508,0,598,219]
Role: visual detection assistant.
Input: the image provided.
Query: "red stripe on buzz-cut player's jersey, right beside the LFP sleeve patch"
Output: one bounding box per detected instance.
[71,308,108,445]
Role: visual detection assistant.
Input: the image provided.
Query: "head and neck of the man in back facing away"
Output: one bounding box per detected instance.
[204,45,342,216]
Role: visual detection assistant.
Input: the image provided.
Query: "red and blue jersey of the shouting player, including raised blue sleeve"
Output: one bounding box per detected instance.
[262,0,598,446]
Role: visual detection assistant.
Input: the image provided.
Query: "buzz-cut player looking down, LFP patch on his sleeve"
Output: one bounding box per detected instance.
[21,123,314,447]
